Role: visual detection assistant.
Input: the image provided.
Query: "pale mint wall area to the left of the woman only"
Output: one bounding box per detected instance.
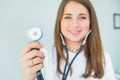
[0,0,59,80]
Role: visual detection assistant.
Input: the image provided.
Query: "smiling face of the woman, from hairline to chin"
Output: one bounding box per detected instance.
[61,1,90,43]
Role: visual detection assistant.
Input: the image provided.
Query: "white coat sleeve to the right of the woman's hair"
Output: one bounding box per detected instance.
[105,53,115,80]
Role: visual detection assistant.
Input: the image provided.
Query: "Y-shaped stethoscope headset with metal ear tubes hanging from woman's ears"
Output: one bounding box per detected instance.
[60,29,92,80]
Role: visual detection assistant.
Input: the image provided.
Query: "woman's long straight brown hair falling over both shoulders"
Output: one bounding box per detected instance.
[54,0,104,78]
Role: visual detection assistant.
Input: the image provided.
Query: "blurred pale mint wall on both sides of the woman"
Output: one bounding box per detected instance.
[0,0,120,80]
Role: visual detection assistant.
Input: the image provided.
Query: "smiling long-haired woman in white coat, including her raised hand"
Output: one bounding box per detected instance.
[21,0,115,80]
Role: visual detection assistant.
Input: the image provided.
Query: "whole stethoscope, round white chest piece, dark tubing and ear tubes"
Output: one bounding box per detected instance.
[27,27,92,80]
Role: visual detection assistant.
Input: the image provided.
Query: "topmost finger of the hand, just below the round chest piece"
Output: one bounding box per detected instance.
[21,42,43,56]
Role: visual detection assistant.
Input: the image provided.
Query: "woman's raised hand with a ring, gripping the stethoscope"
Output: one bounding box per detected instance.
[20,42,45,80]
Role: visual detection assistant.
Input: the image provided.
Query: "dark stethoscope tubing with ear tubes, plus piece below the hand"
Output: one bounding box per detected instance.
[37,29,92,80]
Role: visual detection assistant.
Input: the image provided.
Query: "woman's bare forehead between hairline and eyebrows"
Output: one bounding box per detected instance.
[63,1,88,14]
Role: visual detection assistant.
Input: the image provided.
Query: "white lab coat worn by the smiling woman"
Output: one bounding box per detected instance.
[38,46,115,80]
